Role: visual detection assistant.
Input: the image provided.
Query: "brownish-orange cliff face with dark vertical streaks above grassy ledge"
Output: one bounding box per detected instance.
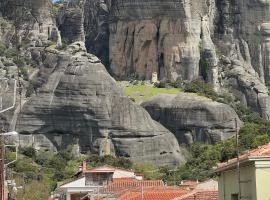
[110,0,216,80]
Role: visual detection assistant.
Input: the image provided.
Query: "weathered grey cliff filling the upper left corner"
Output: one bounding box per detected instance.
[0,0,61,46]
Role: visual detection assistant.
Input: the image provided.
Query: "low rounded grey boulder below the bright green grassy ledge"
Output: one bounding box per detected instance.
[142,93,240,144]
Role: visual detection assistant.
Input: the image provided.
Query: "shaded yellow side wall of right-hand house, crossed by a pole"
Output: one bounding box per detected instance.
[218,165,256,200]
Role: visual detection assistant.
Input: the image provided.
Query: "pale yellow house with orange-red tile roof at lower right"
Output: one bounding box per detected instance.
[215,144,270,200]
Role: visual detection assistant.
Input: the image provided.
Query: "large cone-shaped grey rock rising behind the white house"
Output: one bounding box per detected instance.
[16,43,184,165]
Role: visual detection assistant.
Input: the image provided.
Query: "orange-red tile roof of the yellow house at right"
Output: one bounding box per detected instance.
[216,143,270,171]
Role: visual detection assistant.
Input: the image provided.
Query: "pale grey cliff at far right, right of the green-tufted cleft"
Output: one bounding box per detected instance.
[216,0,270,119]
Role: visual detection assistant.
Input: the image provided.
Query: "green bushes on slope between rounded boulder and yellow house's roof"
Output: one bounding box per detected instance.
[172,113,270,180]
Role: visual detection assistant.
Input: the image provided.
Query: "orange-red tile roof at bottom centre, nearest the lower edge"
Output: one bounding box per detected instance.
[117,187,187,200]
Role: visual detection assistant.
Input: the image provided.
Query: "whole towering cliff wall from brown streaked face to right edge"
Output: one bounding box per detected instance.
[87,0,270,119]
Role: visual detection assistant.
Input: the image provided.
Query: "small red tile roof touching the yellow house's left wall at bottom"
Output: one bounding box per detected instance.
[175,190,218,200]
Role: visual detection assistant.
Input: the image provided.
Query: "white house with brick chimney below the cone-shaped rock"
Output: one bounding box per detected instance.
[54,162,143,200]
